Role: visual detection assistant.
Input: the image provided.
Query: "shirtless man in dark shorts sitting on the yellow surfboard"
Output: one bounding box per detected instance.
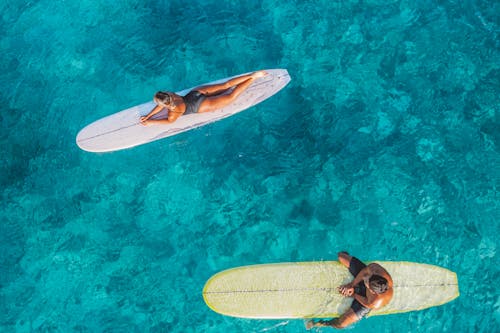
[306,252,393,329]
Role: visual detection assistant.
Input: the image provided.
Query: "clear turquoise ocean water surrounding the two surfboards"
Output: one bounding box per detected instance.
[0,0,500,332]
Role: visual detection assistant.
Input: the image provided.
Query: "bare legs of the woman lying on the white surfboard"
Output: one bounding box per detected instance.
[196,71,267,113]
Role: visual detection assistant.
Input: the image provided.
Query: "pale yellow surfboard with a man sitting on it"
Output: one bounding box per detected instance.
[203,261,459,319]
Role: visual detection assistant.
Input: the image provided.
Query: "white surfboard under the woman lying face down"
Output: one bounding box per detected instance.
[76,69,290,152]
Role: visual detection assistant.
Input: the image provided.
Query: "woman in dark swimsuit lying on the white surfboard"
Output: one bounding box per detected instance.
[140,71,267,125]
